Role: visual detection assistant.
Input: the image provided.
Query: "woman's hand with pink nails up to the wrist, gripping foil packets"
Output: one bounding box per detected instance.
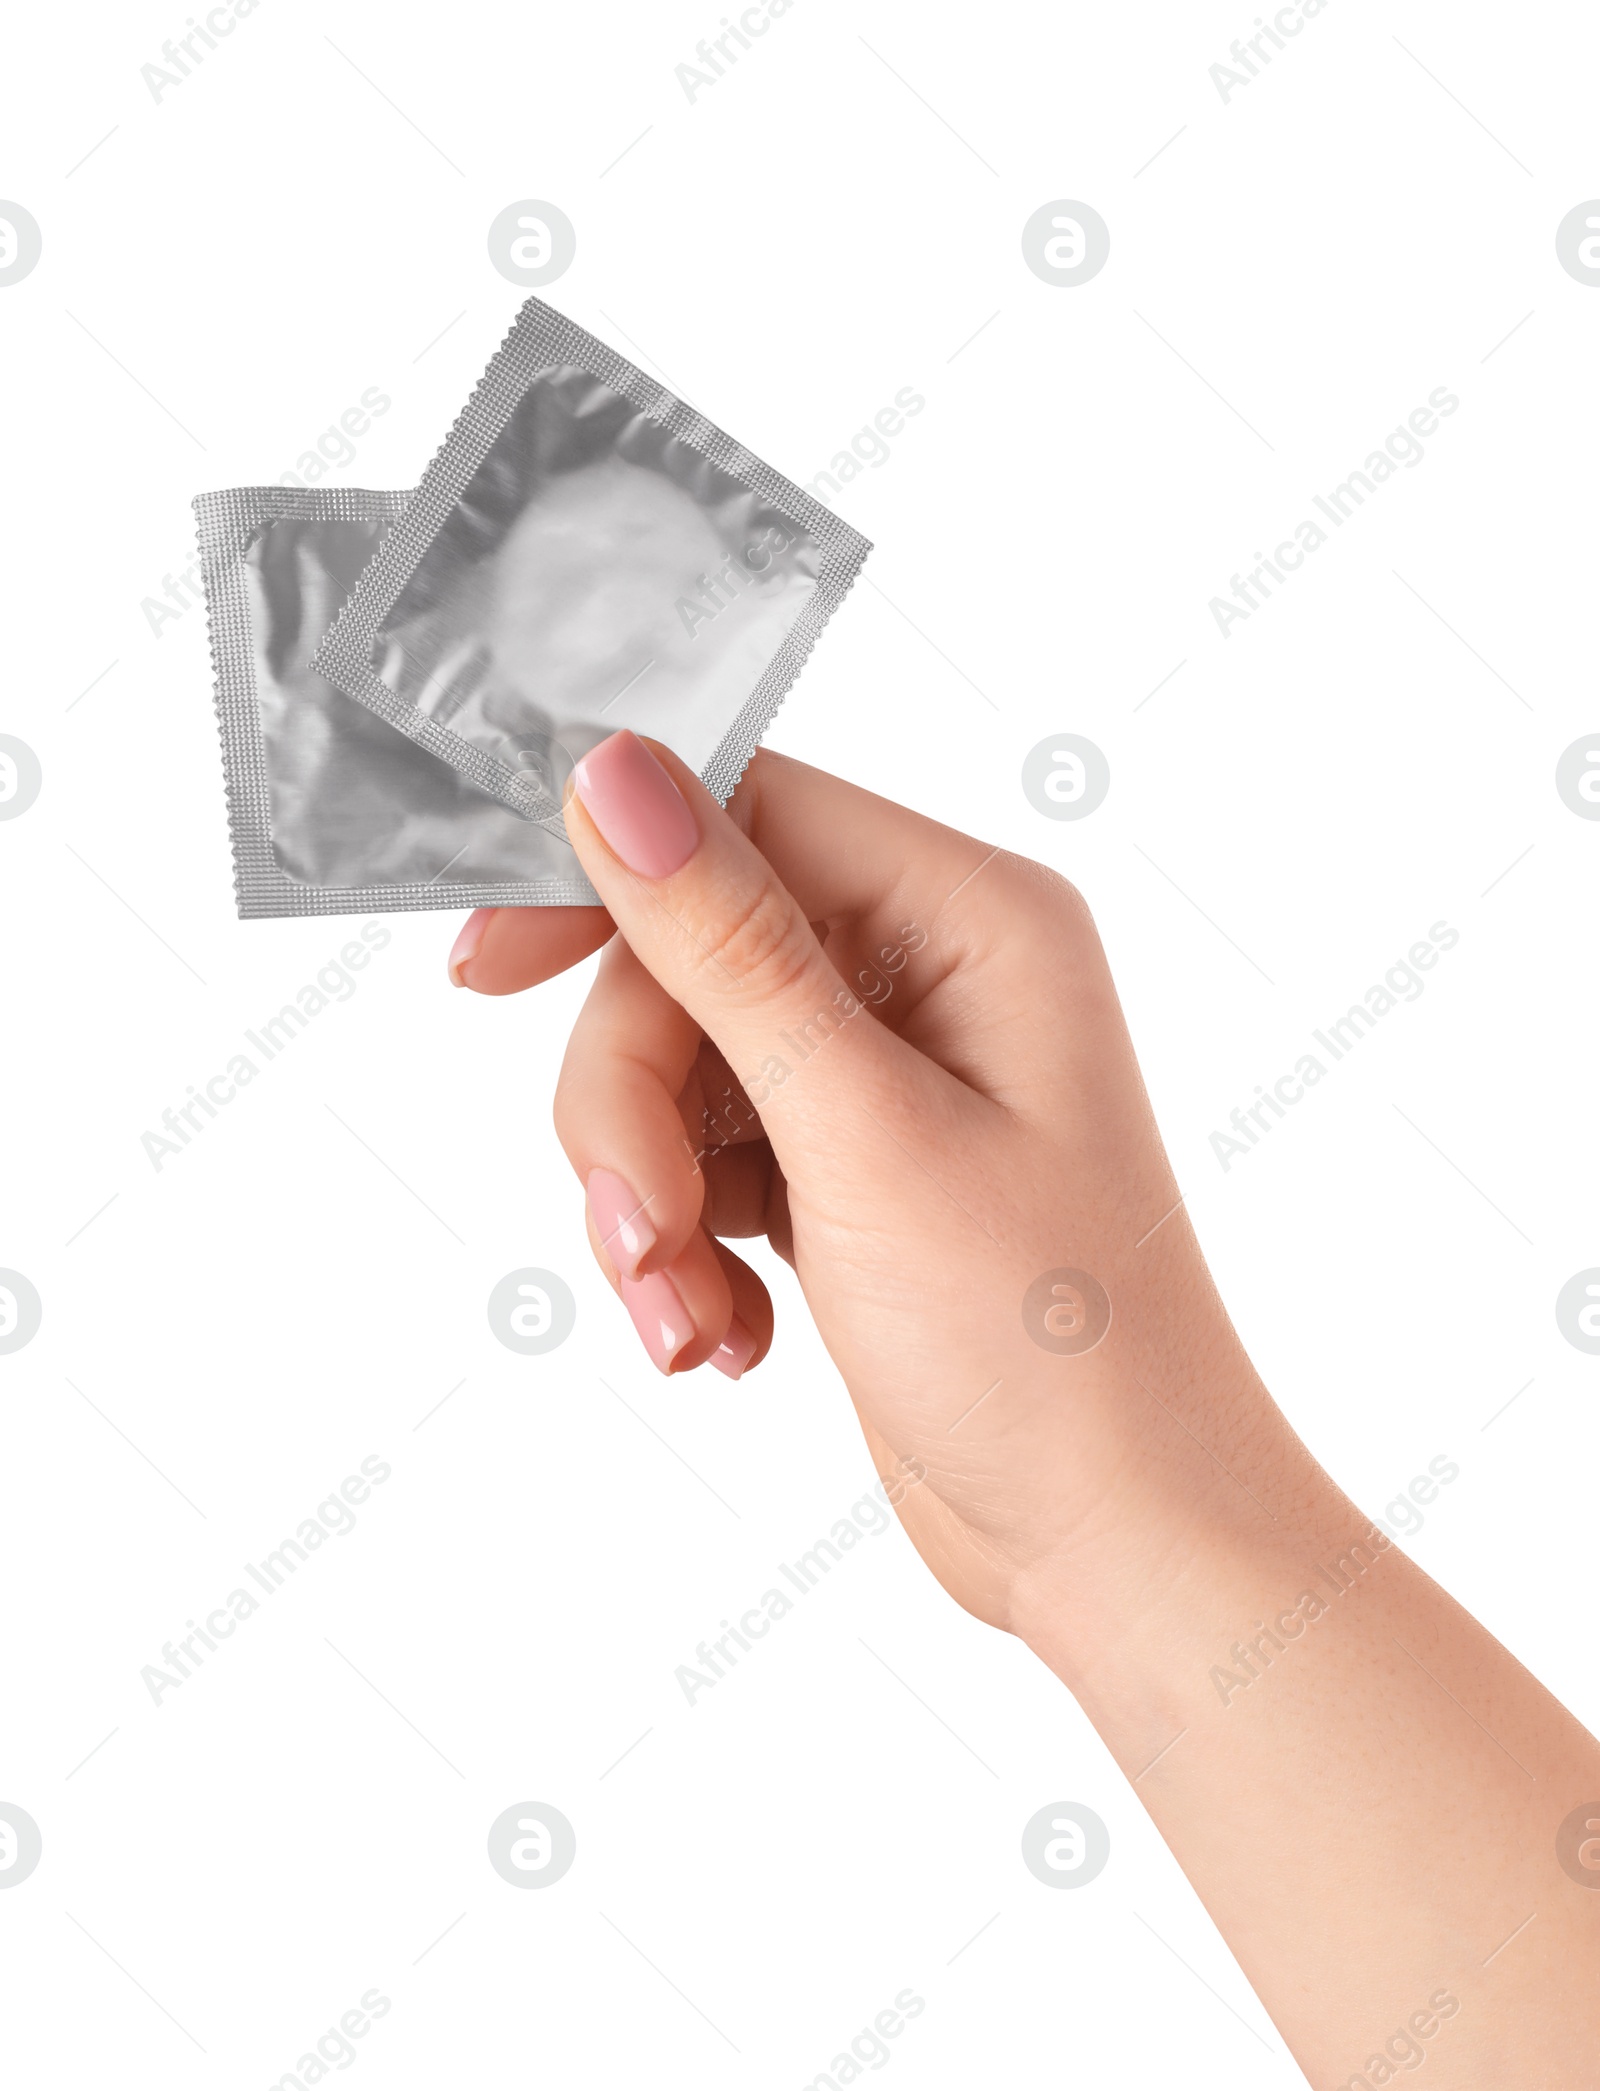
[452,734,1288,1625]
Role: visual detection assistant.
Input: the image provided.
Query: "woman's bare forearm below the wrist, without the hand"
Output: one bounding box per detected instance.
[1023,1397,1600,2091]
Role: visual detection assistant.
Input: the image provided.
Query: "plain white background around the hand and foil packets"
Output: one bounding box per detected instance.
[0,0,1600,2087]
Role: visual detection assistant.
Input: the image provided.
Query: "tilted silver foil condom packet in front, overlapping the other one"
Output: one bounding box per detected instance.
[312,297,870,841]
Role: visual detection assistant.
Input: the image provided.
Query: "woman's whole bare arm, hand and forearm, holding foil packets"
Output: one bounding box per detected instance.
[439,736,1600,2091]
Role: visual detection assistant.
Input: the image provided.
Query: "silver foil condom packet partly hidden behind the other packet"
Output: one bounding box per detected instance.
[195,487,598,918]
